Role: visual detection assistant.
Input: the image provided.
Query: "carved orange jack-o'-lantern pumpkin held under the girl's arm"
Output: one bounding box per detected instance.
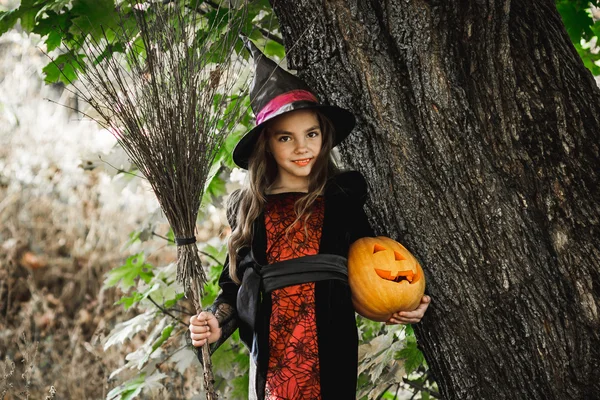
[348,236,425,322]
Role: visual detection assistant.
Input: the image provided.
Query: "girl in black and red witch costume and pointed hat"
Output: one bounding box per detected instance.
[190,38,430,400]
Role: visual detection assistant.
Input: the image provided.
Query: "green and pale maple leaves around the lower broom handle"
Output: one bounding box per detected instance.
[104,238,248,399]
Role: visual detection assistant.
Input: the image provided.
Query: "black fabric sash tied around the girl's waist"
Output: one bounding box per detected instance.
[236,254,348,331]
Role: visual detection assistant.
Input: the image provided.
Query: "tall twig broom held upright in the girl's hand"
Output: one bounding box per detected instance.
[47,1,253,399]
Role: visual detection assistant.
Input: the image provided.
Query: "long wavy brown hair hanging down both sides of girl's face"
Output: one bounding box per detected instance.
[227,110,339,284]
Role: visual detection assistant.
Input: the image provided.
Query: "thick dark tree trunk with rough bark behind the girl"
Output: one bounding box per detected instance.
[272,0,600,400]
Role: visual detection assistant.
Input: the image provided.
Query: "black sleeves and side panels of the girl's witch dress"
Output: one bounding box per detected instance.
[210,171,375,400]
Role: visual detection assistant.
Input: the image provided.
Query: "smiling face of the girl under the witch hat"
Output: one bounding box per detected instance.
[267,110,323,186]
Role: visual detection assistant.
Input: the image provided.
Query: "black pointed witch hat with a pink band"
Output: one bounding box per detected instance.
[233,36,356,169]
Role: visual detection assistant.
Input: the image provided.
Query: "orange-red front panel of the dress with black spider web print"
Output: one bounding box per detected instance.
[265,193,324,400]
